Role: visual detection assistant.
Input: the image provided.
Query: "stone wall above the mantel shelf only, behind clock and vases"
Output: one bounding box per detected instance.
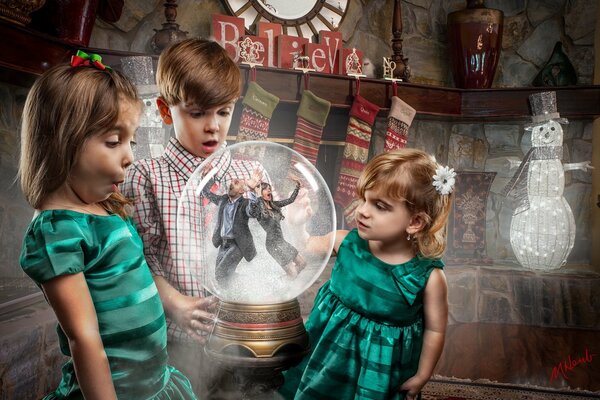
[90,0,598,87]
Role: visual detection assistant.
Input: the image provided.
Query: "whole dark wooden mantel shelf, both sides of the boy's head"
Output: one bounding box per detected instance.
[0,21,600,121]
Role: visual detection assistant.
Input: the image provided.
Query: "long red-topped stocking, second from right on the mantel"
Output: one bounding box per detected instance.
[334,95,379,226]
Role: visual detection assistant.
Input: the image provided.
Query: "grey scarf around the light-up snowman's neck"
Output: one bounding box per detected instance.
[502,146,563,215]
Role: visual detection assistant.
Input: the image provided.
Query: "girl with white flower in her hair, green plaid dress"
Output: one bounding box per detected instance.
[280,149,455,400]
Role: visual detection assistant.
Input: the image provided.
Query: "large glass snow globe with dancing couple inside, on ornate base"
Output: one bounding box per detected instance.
[177,141,335,379]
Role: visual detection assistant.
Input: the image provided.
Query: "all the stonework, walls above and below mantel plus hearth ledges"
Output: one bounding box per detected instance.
[0,0,600,398]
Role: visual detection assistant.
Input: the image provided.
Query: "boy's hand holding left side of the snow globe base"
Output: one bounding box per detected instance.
[172,296,218,344]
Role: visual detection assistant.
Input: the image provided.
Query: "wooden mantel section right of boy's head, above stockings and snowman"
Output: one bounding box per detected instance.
[242,66,600,120]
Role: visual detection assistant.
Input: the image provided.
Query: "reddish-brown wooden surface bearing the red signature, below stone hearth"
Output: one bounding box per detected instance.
[435,323,600,391]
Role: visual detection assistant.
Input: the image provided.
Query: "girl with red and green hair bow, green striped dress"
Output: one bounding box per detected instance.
[19,56,196,400]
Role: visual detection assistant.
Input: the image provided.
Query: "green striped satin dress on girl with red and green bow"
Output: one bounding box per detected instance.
[20,210,196,400]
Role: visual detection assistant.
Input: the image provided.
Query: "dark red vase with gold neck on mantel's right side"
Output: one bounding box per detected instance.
[448,0,504,89]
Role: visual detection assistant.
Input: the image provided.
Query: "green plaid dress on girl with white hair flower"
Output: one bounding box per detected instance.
[280,229,444,400]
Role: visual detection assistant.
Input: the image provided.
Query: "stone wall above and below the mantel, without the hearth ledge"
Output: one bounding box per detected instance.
[0,0,598,288]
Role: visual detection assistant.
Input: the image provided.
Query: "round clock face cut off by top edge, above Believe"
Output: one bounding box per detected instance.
[224,0,350,40]
